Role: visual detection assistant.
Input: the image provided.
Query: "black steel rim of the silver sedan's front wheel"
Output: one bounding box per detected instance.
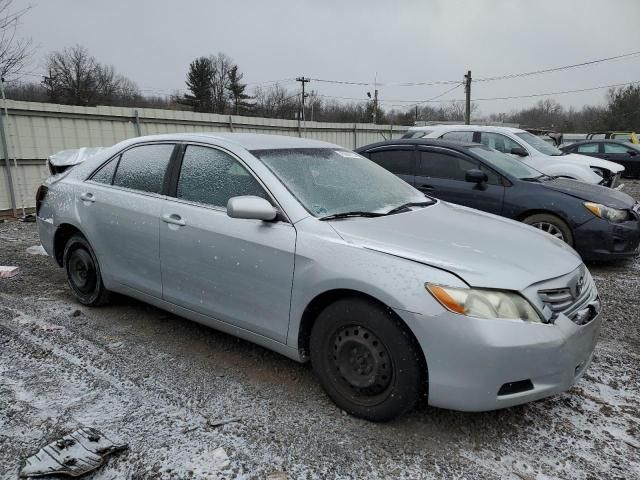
[329,325,395,406]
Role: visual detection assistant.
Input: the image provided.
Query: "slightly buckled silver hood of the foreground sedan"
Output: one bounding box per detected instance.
[330,202,582,291]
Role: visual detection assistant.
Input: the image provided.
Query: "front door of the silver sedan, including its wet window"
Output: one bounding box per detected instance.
[160,145,296,343]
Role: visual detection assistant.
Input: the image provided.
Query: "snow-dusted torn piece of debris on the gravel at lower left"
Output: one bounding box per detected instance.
[20,427,128,477]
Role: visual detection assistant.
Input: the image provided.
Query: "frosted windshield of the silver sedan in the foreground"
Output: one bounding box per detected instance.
[251,148,426,217]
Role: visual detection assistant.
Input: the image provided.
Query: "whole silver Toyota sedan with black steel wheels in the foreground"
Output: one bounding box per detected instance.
[37,134,601,421]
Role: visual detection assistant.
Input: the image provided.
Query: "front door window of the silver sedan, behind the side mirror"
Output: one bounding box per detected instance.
[177,145,268,208]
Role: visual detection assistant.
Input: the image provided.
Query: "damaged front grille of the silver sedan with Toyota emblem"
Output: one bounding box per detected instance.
[538,270,600,325]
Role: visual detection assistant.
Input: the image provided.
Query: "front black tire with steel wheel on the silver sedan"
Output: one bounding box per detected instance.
[310,297,427,422]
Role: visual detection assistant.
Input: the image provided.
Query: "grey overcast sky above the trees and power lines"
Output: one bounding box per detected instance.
[15,0,640,114]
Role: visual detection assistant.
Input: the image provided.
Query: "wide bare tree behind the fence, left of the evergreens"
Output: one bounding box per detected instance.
[43,45,140,105]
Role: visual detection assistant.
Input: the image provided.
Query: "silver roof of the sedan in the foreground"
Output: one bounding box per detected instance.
[112,132,343,150]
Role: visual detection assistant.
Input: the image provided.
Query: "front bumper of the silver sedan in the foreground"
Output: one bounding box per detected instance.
[397,311,602,411]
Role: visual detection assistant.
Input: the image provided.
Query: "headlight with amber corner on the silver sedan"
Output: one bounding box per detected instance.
[424,283,542,323]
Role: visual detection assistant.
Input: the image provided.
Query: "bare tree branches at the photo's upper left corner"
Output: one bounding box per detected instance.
[0,0,33,78]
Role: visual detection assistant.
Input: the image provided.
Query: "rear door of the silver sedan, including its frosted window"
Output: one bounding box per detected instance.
[78,143,175,298]
